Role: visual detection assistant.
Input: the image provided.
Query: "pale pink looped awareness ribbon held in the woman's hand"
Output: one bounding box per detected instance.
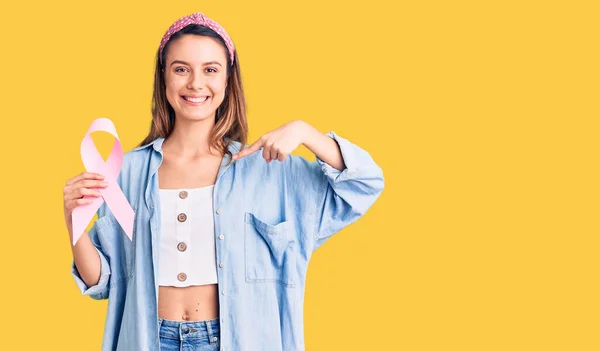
[71,118,135,245]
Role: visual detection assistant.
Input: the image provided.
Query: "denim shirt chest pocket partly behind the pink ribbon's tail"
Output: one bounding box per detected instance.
[97,213,138,286]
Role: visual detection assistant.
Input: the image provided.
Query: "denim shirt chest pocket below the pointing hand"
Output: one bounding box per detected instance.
[244,212,296,287]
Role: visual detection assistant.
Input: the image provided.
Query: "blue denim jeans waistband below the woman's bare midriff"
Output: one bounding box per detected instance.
[158,317,221,351]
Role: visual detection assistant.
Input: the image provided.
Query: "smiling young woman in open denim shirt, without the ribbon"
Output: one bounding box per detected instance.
[64,13,384,351]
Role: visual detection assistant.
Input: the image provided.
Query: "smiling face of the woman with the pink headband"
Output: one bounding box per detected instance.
[164,34,227,120]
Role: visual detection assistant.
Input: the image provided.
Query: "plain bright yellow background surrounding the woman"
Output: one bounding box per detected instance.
[0,0,600,351]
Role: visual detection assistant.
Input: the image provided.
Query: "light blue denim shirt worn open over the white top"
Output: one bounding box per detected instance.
[72,132,384,351]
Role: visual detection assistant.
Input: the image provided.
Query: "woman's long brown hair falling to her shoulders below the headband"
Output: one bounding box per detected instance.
[138,24,248,161]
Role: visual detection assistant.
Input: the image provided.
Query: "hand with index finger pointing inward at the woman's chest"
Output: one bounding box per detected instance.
[233,120,309,163]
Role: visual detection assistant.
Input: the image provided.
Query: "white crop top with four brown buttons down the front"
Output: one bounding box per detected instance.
[158,184,217,287]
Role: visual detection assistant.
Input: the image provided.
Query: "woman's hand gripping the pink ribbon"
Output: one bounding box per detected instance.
[63,172,108,233]
